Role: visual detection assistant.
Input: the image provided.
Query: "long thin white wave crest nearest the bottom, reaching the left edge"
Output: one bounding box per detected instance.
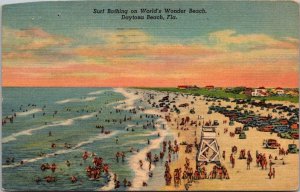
[2,131,118,168]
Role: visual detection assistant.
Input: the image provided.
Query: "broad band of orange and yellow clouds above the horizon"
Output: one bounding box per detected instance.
[3,29,299,87]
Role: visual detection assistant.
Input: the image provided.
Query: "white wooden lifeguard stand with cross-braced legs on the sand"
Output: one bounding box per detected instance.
[197,126,220,163]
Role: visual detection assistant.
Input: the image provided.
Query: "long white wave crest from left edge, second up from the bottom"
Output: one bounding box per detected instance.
[2,113,97,143]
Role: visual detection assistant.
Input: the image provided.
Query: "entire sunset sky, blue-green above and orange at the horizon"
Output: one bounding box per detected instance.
[2,1,299,87]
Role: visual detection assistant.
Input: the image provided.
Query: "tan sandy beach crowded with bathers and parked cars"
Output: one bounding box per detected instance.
[119,90,299,191]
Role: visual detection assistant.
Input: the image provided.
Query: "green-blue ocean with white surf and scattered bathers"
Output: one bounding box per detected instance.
[2,88,172,191]
